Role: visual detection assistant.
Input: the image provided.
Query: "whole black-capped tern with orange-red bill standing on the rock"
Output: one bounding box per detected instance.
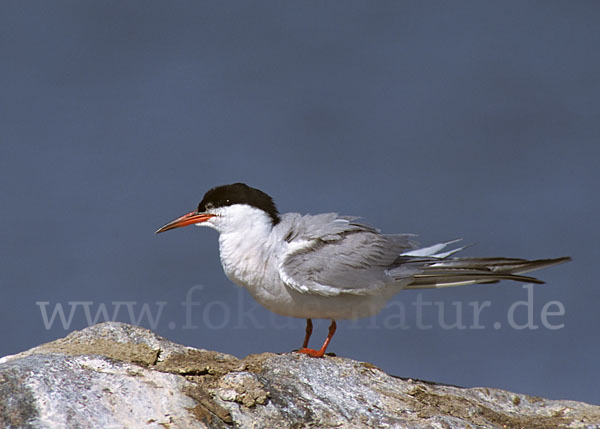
[156,183,570,358]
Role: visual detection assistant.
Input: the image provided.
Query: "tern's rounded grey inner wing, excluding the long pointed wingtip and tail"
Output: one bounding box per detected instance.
[279,213,415,296]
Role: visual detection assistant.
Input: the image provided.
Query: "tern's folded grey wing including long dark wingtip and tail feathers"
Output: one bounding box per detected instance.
[279,213,571,296]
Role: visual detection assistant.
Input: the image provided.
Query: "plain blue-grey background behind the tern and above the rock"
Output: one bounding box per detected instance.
[0,0,600,403]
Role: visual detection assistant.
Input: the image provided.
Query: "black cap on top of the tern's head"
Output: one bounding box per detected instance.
[198,183,280,225]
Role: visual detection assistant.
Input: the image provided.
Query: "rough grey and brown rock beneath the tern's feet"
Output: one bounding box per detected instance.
[0,322,600,429]
